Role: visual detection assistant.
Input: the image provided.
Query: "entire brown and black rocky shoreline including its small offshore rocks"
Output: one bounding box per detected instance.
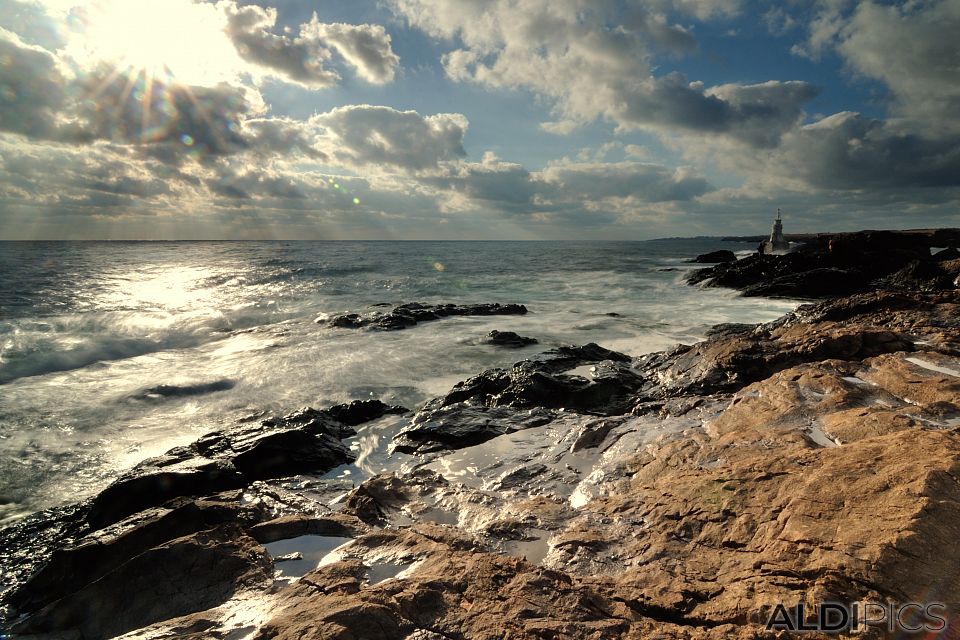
[0,233,960,640]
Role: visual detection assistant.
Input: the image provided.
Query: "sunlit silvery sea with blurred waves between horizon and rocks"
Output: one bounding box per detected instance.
[0,238,798,526]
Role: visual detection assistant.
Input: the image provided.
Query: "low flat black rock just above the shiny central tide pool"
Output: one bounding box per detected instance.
[393,402,555,453]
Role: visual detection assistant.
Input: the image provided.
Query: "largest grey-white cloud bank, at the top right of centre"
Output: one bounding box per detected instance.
[392,0,817,146]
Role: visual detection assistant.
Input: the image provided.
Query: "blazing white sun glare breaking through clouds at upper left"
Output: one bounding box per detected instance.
[70,0,240,85]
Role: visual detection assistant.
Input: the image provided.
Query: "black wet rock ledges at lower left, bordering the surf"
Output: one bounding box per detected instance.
[0,400,405,638]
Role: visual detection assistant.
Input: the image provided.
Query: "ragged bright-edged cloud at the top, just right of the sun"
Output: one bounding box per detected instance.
[218,0,400,89]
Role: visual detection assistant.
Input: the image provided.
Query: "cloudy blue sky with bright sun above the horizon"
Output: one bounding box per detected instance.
[0,0,960,240]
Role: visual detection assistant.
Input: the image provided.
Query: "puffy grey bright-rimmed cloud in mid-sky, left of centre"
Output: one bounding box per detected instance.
[310,105,468,171]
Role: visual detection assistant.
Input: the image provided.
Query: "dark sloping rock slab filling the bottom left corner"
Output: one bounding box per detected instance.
[13,526,273,639]
